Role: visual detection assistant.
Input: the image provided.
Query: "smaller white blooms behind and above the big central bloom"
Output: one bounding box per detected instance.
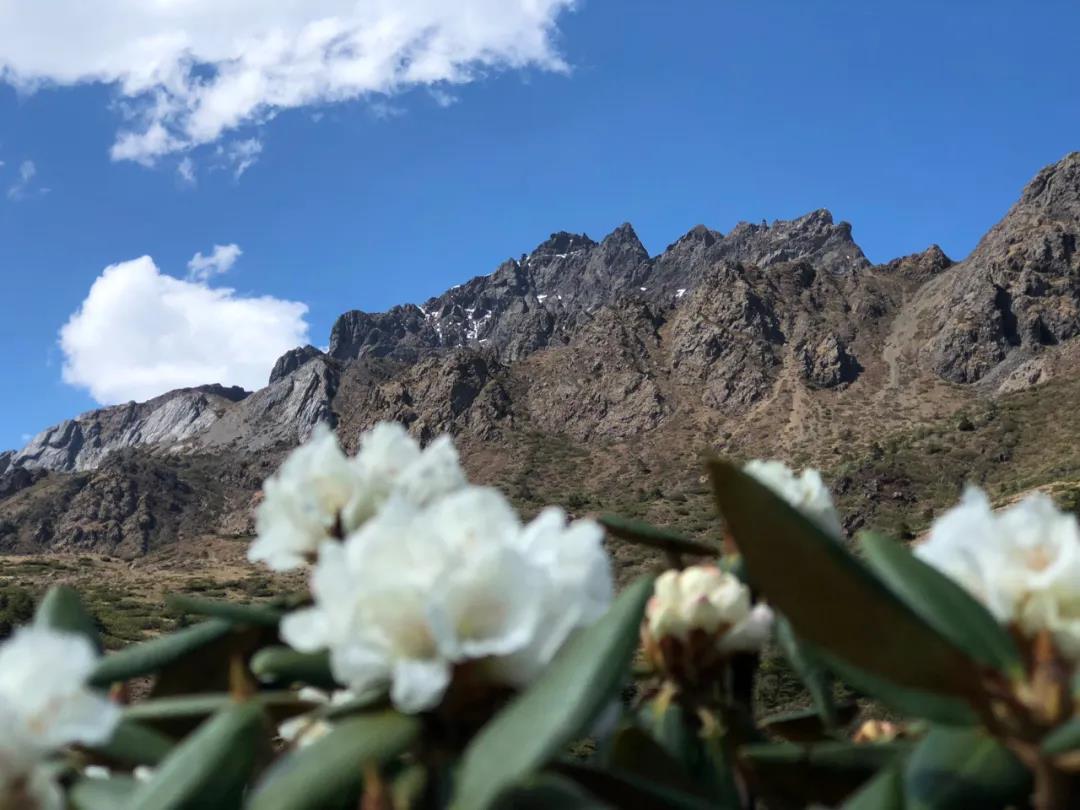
[247,422,467,570]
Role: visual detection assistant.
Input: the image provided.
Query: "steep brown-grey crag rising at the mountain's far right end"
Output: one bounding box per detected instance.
[923,152,1080,382]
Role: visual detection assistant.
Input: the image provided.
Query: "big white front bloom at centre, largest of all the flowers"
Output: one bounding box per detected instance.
[282,487,610,712]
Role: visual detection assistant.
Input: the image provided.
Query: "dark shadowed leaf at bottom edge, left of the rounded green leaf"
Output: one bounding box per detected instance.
[739,742,909,807]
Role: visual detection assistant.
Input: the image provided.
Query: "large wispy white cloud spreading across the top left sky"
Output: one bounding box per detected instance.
[0,0,576,163]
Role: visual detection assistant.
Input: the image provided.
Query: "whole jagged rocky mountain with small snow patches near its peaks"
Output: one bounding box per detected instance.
[6,153,1080,554]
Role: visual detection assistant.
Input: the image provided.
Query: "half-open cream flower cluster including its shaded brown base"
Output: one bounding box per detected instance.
[642,565,772,679]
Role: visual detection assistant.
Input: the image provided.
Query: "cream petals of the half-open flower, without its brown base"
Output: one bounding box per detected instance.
[645,565,772,652]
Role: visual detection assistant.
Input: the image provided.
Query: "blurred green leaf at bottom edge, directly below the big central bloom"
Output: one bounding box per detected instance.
[247,711,421,810]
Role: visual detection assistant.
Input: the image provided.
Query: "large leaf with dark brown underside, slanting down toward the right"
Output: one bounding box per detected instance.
[708,461,977,694]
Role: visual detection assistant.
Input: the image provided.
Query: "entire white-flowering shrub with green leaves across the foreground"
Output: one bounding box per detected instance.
[6,424,1080,810]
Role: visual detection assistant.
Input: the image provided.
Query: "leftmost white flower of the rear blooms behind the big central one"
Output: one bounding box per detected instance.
[247,424,361,571]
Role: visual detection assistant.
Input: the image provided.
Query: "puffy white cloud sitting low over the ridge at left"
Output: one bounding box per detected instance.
[59,256,309,404]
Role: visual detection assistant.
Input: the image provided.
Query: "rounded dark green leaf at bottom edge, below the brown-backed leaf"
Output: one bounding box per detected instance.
[904,728,1031,810]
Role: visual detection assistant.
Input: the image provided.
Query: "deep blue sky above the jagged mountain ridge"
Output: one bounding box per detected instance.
[0,0,1080,448]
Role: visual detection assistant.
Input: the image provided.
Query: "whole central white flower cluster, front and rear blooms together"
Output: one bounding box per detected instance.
[264,424,613,712]
